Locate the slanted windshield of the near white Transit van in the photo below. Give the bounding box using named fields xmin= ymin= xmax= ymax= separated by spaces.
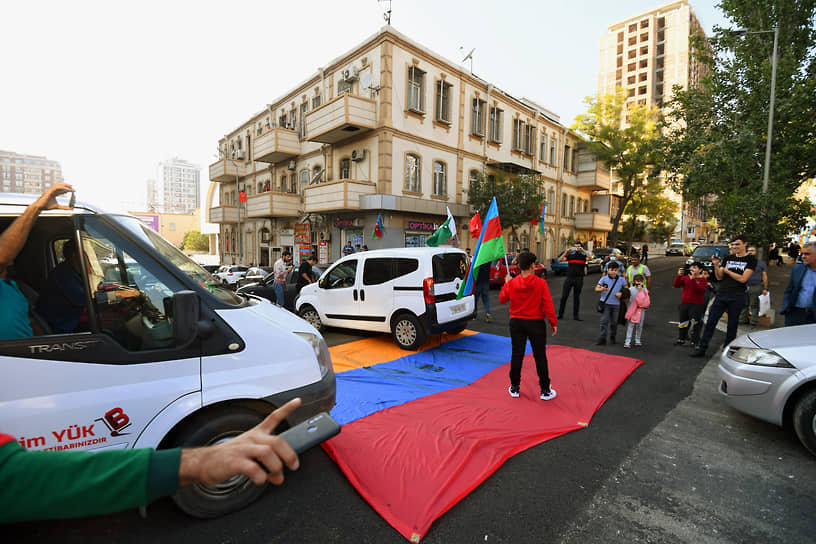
xmin=115 ymin=215 xmax=243 ymax=306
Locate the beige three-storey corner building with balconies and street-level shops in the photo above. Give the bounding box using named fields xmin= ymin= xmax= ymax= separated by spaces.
xmin=207 ymin=26 xmax=613 ymax=265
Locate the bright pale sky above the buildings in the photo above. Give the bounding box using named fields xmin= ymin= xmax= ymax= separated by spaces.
xmin=0 ymin=0 xmax=728 ymax=211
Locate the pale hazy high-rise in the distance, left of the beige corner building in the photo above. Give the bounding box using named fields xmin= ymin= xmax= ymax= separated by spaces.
xmin=147 ymin=157 xmax=201 ymax=214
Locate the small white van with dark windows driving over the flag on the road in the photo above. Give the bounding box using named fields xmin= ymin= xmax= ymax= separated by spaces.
xmin=295 ymin=247 xmax=475 ymax=350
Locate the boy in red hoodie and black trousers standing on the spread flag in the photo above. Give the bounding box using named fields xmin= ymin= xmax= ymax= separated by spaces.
xmin=499 ymin=251 xmax=558 ymax=400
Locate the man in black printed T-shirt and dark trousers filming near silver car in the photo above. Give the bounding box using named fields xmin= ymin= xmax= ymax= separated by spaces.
xmin=691 ymin=235 xmax=757 ymax=357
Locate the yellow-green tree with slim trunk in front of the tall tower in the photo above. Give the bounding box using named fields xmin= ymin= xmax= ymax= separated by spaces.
xmin=573 ymin=88 xmax=660 ymax=246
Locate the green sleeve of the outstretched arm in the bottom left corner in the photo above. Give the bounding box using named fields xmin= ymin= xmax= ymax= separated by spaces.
xmin=0 ymin=442 xmax=181 ymax=523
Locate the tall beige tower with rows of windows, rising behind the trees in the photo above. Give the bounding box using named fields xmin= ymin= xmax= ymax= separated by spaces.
xmin=598 ymin=0 xmax=708 ymax=240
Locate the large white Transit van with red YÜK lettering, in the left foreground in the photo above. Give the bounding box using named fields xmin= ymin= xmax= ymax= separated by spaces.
xmin=0 ymin=195 xmax=335 ymax=517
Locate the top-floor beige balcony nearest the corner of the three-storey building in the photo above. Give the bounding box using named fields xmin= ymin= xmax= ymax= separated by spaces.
xmin=306 ymin=93 xmax=377 ymax=144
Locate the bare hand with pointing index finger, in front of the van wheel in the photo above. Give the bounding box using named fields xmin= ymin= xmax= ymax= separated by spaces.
xmin=179 ymin=398 xmax=301 ymax=486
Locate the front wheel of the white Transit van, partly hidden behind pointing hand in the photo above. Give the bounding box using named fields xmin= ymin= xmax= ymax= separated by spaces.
xmin=172 ymin=408 xmax=266 ymax=519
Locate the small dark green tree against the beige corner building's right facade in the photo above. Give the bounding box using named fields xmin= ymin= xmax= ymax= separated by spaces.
xmin=466 ymin=172 xmax=544 ymax=234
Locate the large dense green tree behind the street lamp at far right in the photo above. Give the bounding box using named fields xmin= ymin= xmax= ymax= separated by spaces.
xmin=662 ymin=0 xmax=816 ymax=247
